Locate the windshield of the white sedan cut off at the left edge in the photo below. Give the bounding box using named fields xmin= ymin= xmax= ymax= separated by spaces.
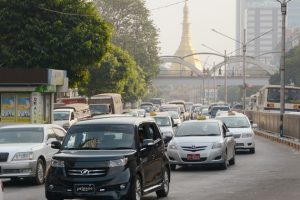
xmin=0 ymin=127 xmax=44 ymax=144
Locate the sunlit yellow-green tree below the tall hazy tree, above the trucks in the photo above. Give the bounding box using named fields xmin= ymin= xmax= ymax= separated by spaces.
xmin=81 ymin=45 xmax=145 ymax=102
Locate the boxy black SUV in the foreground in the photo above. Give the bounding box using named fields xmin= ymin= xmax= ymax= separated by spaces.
xmin=45 ymin=116 xmax=170 ymax=200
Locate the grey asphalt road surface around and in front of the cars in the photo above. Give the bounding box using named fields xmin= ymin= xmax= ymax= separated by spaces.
xmin=4 ymin=136 xmax=300 ymax=200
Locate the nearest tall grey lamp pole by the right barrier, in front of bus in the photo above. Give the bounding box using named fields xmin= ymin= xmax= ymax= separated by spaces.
xmin=276 ymin=0 xmax=291 ymax=137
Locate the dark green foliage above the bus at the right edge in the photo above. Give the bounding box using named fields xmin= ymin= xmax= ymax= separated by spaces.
xmin=269 ymin=45 xmax=300 ymax=86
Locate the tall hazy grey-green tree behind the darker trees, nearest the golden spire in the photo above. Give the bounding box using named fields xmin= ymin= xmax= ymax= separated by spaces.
xmin=94 ymin=0 xmax=159 ymax=83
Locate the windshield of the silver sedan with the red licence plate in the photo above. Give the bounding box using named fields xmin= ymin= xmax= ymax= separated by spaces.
xmin=175 ymin=122 xmax=221 ymax=137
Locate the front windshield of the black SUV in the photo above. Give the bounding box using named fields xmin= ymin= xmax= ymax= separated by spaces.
xmin=63 ymin=124 xmax=135 ymax=150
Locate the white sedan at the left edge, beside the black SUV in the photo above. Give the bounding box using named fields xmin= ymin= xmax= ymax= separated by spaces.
xmin=0 ymin=124 xmax=66 ymax=184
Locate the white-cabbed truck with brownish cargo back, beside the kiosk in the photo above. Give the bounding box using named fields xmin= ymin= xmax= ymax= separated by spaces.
xmin=53 ymin=103 xmax=91 ymax=130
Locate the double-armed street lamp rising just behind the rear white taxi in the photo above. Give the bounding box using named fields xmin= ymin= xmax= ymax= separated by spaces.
xmin=211 ymin=29 xmax=272 ymax=112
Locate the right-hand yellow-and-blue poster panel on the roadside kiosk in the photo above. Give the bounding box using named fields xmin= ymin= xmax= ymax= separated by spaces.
xmin=17 ymin=94 xmax=30 ymax=122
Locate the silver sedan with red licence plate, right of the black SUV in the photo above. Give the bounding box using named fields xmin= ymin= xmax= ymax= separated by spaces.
xmin=167 ymin=119 xmax=235 ymax=170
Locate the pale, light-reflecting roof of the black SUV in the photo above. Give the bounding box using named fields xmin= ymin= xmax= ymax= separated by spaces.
xmin=75 ymin=115 xmax=155 ymax=125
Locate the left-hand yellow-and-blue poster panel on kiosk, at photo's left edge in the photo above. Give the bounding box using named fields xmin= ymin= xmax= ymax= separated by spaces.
xmin=1 ymin=94 xmax=16 ymax=122
